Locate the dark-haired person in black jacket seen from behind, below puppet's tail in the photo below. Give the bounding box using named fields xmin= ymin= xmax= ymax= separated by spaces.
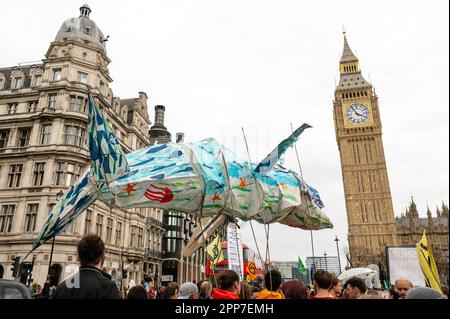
xmin=52 ymin=235 xmax=121 ymax=299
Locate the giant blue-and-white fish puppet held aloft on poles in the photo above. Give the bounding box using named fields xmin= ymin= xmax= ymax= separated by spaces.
xmin=28 ymin=94 xmax=333 ymax=254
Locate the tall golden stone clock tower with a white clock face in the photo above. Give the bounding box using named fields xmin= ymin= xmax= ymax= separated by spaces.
xmin=333 ymin=32 xmax=397 ymax=267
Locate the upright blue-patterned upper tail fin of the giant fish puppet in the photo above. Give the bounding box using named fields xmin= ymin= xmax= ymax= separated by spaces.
xmin=88 ymin=93 xmax=128 ymax=185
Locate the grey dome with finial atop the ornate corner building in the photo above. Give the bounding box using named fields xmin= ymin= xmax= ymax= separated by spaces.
xmin=56 ymin=4 xmax=106 ymax=49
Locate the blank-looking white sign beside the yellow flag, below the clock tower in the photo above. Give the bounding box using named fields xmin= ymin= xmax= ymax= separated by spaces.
xmin=388 ymin=247 xmax=425 ymax=287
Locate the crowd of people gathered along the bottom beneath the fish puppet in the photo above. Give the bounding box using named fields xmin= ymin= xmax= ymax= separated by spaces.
xmin=44 ymin=235 xmax=448 ymax=299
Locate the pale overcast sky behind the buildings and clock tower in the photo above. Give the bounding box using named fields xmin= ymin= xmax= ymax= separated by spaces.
xmin=0 ymin=0 xmax=449 ymax=260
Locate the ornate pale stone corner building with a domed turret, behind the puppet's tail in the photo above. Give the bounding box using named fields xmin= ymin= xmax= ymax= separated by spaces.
xmin=0 ymin=5 xmax=164 ymax=292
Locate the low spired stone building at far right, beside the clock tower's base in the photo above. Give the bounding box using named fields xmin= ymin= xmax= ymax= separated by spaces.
xmin=395 ymin=198 xmax=449 ymax=284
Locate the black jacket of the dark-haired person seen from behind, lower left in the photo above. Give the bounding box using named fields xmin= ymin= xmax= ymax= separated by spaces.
xmin=52 ymin=266 xmax=122 ymax=299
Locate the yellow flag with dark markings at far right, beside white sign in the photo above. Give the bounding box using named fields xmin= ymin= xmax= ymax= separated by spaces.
xmin=416 ymin=230 xmax=442 ymax=293
